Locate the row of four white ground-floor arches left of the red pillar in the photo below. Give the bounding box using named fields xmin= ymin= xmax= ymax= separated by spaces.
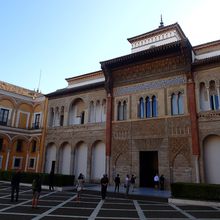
xmin=45 ymin=141 xmax=106 ymax=181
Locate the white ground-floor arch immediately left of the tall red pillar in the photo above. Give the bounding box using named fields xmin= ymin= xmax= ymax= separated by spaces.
xmin=92 ymin=141 xmax=106 ymax=180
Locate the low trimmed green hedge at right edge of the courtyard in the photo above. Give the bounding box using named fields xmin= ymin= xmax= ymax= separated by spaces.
xmin=171 ymin=183 xmax=220 ymax=201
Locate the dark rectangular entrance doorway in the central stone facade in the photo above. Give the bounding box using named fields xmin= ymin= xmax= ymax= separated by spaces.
xmin=139 ymin=151 xmax=158 ymax=187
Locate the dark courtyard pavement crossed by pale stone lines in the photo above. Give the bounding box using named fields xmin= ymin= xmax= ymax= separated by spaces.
xmin=0 ymin=182 xmax=220 ymax=220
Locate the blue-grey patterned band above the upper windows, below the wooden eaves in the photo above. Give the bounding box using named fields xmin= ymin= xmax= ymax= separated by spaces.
xmin=114 ymin=76 xmax=186 ymax=96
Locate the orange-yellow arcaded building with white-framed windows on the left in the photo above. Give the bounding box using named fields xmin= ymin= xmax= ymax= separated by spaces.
xmin=0 ymin=81 xmax=47 ymax=172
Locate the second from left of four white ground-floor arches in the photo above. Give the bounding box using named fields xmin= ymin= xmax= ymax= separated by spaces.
xmin=59 ymin=143 xmax=71 ymax=175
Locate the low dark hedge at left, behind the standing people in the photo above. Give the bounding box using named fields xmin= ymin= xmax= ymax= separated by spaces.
xmin=0 ymin=171 xmax=74 ymax=186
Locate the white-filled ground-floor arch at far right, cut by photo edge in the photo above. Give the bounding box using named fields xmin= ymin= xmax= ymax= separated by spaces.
xmin=203 ymin=135 xmax=220 ymax=184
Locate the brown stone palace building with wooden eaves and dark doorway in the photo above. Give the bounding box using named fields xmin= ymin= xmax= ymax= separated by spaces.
xmin=44 ymin=23 xmax=220 ymax=187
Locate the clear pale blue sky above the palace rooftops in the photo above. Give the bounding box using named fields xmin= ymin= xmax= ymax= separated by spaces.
xmin=0 ymin=0 xmax=220 ymax=94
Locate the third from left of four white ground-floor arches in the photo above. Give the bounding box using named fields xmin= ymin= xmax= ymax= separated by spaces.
xmin=74 ymin=142 xmax=88 ymax=178
